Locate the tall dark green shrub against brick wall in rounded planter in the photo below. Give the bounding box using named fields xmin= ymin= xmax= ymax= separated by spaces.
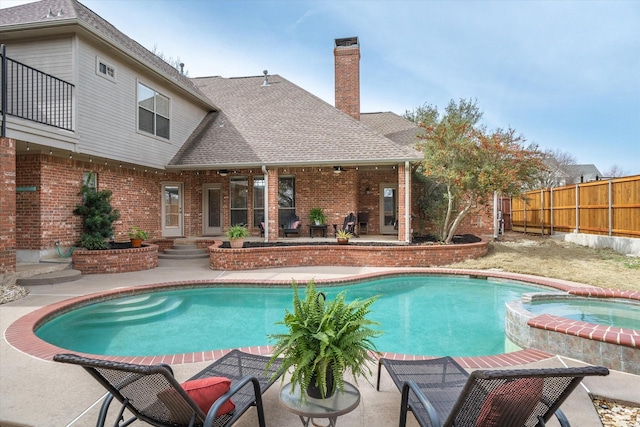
xmin=73 ymin=177 xmax=120 ymax=250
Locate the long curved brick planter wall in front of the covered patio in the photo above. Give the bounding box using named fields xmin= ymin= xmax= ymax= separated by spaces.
xmin=209 ymin=239 xmax=489 ymax=270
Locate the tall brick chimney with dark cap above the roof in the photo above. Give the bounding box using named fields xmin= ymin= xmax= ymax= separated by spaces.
xmin=333 ymin=37 xmax=360 ymax=121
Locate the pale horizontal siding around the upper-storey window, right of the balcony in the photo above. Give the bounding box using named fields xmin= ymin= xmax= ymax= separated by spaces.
xmin=76 ymin=40 xmax=207 ymax=168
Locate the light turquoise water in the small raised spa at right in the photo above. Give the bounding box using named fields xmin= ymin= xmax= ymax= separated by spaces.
xmin=523 ymin=298 xmax=640 ymax=330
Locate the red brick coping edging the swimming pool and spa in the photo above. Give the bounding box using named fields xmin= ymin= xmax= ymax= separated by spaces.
xmin=4 ymin=268 xmax=640 ymax=369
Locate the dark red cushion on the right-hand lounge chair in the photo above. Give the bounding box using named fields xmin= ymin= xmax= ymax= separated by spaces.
xmin=476 ymin=378 xmax=544 ymax=427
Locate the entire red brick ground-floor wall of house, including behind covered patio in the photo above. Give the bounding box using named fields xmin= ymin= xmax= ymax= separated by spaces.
xmin=15 ymin=155 xmax=493 ymax=263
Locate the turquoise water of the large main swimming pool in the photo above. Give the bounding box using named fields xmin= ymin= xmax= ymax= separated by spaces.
xmin=36 ymin=276 xmax=540 ymax=356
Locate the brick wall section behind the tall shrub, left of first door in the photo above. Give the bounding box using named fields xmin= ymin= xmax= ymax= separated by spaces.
xmin=16 ymin=153 xmax=172 ymax=250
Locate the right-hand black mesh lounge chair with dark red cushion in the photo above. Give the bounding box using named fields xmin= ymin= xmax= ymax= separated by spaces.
xmin=377 ymin=357 xmax=609 ymax=427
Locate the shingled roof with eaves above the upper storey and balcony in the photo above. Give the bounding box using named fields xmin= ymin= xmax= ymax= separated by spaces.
xmin=0 ymin=0 xmax=215 ymax=109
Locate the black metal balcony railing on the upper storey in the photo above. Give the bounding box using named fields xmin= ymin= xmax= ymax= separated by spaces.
xmin=0 ymin=45 xmax=74 ymax=136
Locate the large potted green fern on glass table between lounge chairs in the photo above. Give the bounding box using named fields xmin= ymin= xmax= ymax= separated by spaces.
xmin=269 ymin=280 xmax=382 ymax=400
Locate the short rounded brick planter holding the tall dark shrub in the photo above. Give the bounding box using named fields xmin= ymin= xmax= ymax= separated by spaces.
xmin=71 ymin=245 xmax=158 ymax=274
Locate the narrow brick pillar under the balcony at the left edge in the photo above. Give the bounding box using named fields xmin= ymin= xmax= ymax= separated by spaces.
xmin=0 ymin=138 xmax=16 ymax=274
